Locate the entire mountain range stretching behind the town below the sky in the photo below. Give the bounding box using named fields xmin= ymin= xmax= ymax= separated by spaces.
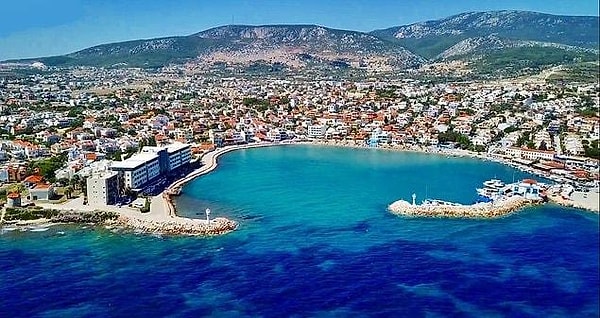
xmin=3 ymin=10 xmax=599 ymax=75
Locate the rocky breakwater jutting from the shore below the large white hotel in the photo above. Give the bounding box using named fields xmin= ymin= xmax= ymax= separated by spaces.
xmin=115 ymin=216 xmax=238 ymax=236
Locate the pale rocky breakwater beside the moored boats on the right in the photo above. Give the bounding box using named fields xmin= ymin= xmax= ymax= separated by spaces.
xmin=388 ymin=197 xmax=541 ymax=219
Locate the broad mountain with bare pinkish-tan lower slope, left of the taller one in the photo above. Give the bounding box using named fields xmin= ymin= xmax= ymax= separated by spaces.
xmin=9 ymin=25 xmax=423 ymax=67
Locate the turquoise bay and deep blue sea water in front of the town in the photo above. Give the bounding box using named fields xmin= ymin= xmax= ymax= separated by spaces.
xmin=0 ymin=145 xmax=600 ymax=317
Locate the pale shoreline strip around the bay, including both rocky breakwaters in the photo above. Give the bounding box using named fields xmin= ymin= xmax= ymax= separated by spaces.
xmin=0 ymin=140 xmax=599 ymax=236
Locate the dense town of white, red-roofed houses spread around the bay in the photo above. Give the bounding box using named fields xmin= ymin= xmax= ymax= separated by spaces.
xmin=0 ymin=65 xmax=600 ymax=210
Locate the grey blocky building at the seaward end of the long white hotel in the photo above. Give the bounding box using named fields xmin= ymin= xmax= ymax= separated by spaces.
xmin=86 ymin=171 xmax=119 ymax=206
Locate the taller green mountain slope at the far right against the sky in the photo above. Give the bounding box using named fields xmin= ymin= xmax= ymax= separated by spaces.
xmin=371 ymin=11 xmax=599 ymax=58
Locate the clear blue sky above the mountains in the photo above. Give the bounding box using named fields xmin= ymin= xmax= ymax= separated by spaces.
xmin=0 ymin=0 xmax=598 ymax=60
